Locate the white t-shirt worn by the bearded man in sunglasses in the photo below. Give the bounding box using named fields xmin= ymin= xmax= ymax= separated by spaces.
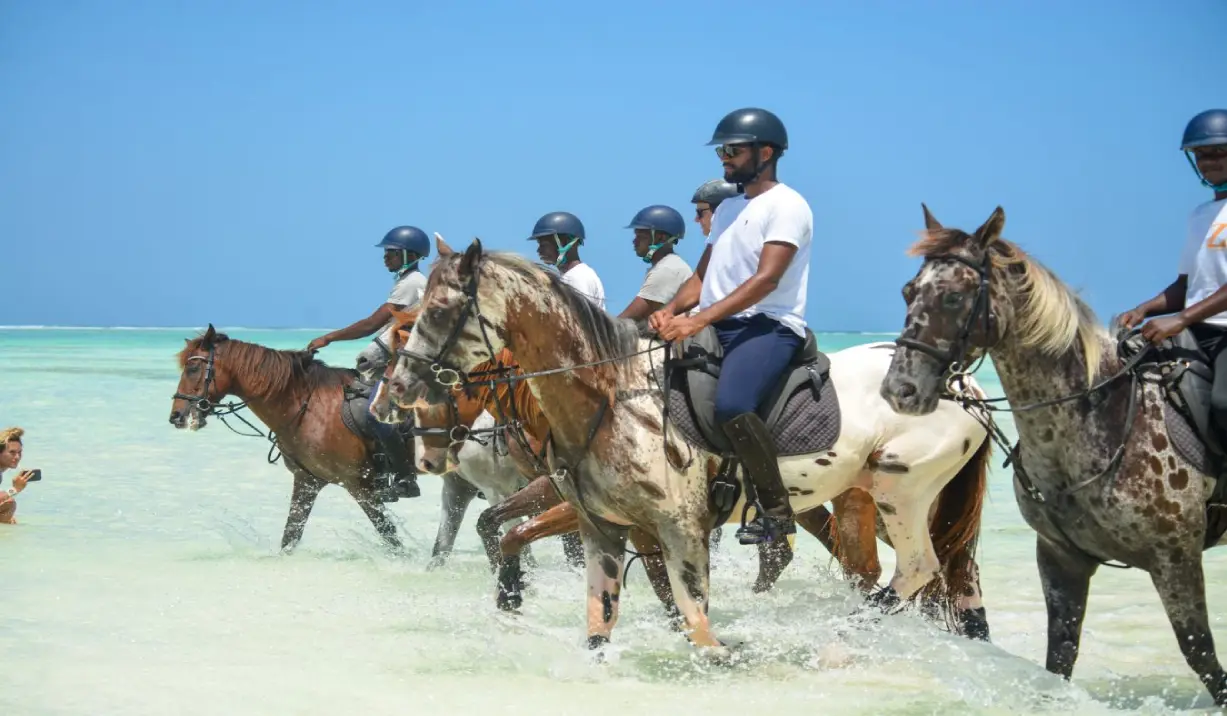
xmin=698 ymin=184 xmax=814 ymax=337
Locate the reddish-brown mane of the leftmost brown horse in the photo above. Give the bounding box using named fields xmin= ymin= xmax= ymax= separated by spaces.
xmin=178 ymin=333 xmax=357 ymax=397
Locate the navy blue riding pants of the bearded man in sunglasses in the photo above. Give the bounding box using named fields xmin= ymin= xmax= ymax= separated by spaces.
xmin=712 ymin=314 xmax=802 ymax=425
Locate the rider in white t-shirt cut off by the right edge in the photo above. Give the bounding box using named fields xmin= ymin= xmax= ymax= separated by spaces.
xmin=1118 ymin=109 xmax=1227 ymax=430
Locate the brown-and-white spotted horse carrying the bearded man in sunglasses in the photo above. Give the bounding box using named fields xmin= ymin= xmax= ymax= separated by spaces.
xmin=388 ymin=239 xmax=988 ymax=655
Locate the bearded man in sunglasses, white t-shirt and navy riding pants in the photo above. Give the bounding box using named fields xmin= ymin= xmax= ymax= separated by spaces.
xmin=650 ymin=108 xmax=814 ymax=544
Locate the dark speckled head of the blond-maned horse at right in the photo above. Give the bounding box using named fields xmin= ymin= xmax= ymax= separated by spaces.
xmin=881 ymin=205 xmax=1012 ymax=416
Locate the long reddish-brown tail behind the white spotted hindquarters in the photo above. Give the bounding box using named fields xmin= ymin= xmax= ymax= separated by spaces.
xmin=921 ymin=435 xmax=993 ymax=627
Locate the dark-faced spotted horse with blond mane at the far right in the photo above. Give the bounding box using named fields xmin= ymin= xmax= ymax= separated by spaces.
xmin=881 ymin=207 xmax=1227 ymax=705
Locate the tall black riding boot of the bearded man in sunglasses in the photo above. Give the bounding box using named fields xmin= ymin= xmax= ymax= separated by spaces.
xmin=724 ymin=413 xmax=796 ymax=544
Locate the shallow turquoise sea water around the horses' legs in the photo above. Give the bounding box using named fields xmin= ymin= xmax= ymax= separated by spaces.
xmin=0 ymin=329 xmax=1227 ymax=716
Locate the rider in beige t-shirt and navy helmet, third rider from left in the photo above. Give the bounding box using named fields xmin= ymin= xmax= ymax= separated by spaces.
xmin=618 ymin=204 xmax=693 ymax=321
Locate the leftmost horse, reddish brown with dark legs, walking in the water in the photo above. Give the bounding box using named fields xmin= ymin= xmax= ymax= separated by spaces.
xmin=171 ymin=324 xmax=401 ymax=552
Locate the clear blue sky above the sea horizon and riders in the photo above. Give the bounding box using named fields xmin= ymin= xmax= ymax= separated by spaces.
xmin=0 ymin=0 xmax=1227 ymax=331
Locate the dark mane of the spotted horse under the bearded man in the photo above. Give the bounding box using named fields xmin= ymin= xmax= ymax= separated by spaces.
xmin=485 ymin=251 xmax=642 ymax=379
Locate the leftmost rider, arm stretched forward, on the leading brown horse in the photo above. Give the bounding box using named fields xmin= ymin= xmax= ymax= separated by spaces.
xmin=307 ymin=227 xmax=431 ymax=499
